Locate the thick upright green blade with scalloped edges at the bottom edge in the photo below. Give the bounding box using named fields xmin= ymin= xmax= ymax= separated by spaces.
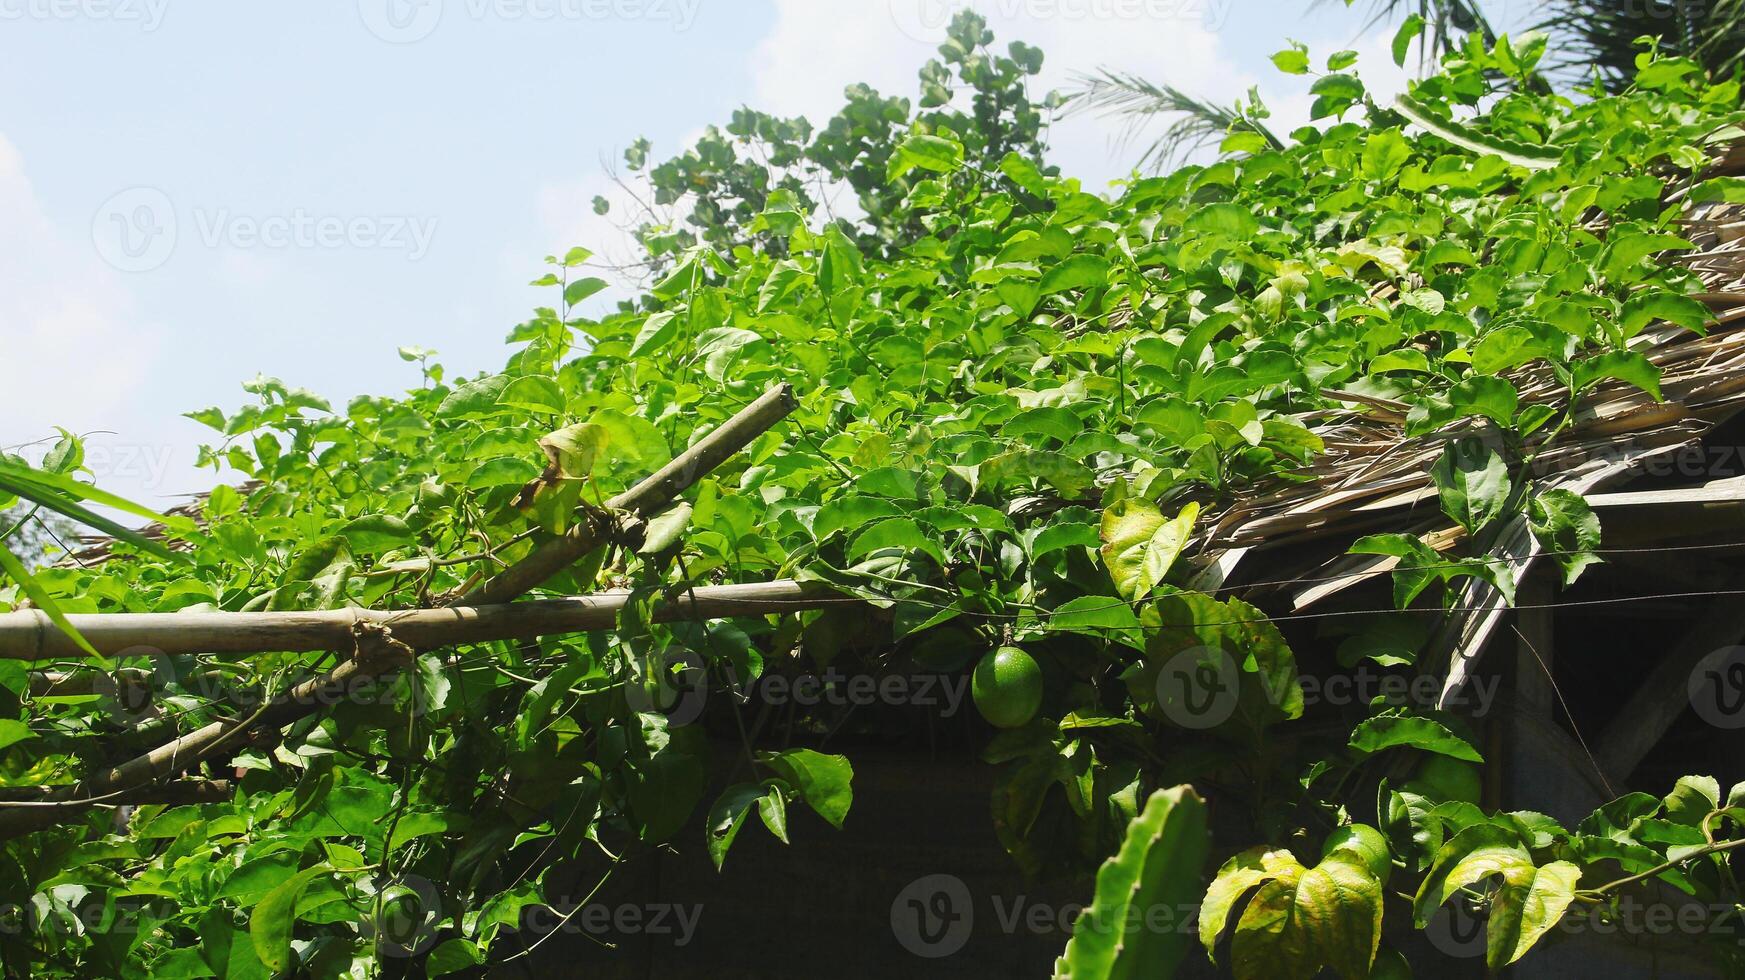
xmin=1054 ymin=786 xmax=1211 ymax=980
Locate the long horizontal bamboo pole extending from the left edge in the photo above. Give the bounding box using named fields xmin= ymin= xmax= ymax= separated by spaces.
xmin=0 ymin=579 xmax=853 ymax=659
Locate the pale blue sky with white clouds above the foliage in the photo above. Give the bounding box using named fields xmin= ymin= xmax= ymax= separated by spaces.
xmin=0 ymin=0 xmax=1528 ymax=506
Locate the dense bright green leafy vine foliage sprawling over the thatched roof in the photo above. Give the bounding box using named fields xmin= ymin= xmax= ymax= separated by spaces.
xmin=0 ymin=16 xmax=1745 ymax=977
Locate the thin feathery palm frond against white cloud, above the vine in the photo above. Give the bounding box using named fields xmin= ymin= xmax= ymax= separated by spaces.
xmin=1068 ymin=70 xmax=1284 ymax=173
